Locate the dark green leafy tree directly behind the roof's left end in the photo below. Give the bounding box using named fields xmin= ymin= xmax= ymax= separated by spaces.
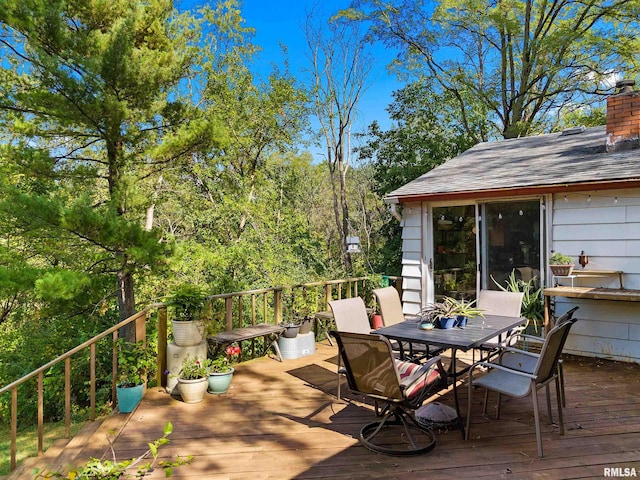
xmin=358 ymin=81 xmax=485 ymax=275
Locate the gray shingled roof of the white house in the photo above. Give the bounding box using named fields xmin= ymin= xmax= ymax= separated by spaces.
xmin=387 ymin=127 xmax=640 ymax=198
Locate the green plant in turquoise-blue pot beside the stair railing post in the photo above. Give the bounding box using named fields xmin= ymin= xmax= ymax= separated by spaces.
xmin=116 ymin=339 xmax=155 ymax=413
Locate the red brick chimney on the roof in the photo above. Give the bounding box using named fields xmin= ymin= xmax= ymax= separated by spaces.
xmin=607 ymin=80 xmax=640 ymax=152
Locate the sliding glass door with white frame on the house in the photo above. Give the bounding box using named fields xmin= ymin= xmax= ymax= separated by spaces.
xmin=426 ymin=199 xmax=544 ymax=301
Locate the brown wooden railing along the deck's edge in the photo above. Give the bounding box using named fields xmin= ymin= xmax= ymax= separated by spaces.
xmin=0 ymin=277 xmax=401 ymax=471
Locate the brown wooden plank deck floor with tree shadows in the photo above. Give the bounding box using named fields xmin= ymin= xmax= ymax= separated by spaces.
xmin=11 ymin=344 xmax=640 ymax=480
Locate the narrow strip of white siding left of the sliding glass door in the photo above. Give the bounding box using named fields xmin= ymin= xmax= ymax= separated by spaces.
xmin=402 ymin=203 xmax=422 ymax=313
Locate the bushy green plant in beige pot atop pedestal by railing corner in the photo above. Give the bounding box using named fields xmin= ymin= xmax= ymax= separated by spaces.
xmin=166 ymin=284 xmax=207 ymax=347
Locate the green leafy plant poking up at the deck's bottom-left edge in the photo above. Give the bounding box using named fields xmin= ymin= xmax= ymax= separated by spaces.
xmin=35 ymin=422 xmax=193 ymax=480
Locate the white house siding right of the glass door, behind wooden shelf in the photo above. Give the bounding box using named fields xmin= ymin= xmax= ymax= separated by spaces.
xmin=552 ymin=189 xmax=640 ymax=363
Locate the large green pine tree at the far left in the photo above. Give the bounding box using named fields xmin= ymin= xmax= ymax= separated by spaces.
xmin=0 ymin=0 xmax=238 ymax=340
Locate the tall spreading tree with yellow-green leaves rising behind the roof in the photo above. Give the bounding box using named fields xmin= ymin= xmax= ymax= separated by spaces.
xmin=349 ymin=0 xmax=640 ymax=142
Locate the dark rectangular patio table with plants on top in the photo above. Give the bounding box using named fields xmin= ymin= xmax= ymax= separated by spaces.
xmin=373 ymin=315 xmax=527 ymax=436
